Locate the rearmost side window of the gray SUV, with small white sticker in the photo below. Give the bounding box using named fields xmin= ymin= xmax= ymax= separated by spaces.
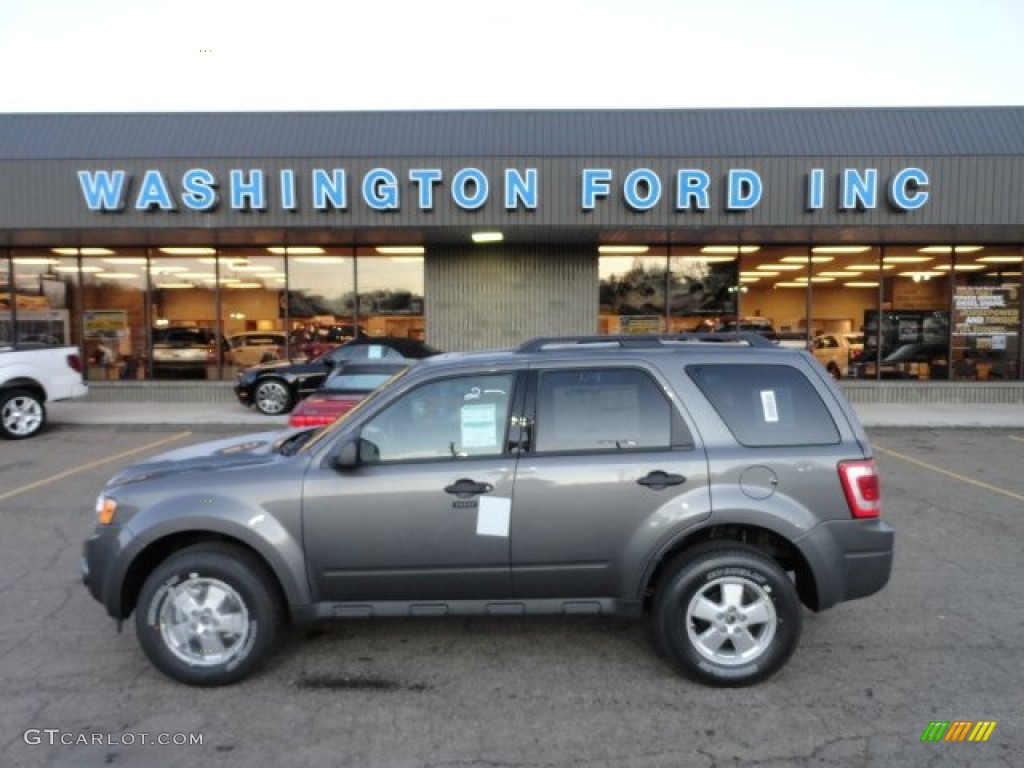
xmin=686 ymin=364 xmax=840 ymax=447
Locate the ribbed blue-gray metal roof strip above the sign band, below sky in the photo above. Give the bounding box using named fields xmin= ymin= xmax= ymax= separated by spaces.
xmin=0 ymin=108 xmax=1024 ymax=160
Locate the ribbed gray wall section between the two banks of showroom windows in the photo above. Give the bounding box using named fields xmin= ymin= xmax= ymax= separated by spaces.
xmin=424 ymin=246 xmax=598 ymax=350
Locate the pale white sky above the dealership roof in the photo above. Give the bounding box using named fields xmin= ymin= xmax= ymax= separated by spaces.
xmin=0 ymin=0 xmax=1024 ymax=112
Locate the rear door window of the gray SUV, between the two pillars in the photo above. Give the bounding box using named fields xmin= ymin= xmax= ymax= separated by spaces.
xmin=536 ymin=368 xmax=686 ymax=453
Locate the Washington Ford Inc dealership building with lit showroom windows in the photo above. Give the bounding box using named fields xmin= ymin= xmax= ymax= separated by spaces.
xmin=0 ymin=108 xmax=1024 ymax=384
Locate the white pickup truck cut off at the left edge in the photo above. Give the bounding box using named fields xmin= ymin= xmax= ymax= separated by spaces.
xmin=0 ymin=341 xmax=89 ymax=440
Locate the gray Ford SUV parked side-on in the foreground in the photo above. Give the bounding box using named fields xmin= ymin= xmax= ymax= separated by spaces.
xmin=82 ymin=334 xmax=893 ymax=686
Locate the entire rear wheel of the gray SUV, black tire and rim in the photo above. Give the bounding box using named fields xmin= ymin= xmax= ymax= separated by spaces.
xmin=652 ymin=544 xmax=803 ymax=687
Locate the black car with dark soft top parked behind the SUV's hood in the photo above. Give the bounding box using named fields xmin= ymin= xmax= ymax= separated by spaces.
xmin=234 ymin=336 xmax=438 ymax=416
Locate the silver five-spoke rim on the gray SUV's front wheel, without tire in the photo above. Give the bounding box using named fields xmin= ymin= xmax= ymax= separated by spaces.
xmin=160 ymin=575 xmax=250 ymax=667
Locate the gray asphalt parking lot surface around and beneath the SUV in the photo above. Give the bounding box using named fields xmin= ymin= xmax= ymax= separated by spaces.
xmin=0 ymin=425 xmax=1024 ymax=768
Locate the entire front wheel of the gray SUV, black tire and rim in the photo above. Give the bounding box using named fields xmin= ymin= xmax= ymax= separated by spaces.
xmin=135 ymin=544 xmax=285 ymax=686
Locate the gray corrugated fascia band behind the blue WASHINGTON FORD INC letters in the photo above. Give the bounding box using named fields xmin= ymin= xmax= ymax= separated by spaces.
xmin=8 ymin=154 xmax=1024 ymax=242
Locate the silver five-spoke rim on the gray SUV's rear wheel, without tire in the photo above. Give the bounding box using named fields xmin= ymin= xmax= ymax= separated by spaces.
xmin=686 ymin=575 xmax=778 ymax=667
